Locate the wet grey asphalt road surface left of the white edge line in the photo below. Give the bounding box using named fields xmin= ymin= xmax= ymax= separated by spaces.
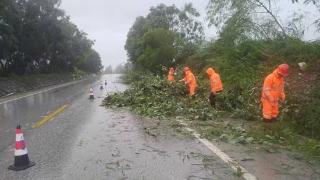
xmin=0 ymin=75 xmax=238 ymax=180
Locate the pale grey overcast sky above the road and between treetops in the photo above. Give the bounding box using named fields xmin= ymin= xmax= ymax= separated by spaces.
xmin=61 ymin=0 xmax=319 ymax=67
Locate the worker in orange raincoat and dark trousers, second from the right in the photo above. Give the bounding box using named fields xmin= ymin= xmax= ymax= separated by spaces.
xmin=206 ymin=68 xmax=223 ymax=107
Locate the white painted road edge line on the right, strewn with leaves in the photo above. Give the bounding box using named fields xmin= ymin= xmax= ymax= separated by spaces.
xmin=178 ymin=120 xmax=257 ymax=180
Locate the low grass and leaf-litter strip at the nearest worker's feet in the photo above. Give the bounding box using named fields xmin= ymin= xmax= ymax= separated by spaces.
xmin=190 ymin=118 xmax=320 ymax=162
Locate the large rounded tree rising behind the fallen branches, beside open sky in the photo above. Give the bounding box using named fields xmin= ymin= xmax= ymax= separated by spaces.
xmin=125 ymin=4 xmax=203 ymax=71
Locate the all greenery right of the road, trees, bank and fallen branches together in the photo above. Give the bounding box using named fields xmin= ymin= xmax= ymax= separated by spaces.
xmin=104 ymin=0 xmax=320 ymax=159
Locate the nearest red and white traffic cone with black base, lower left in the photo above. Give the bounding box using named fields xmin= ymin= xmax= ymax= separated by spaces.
xmin=8 ymin=125 xmax=36 ymax=171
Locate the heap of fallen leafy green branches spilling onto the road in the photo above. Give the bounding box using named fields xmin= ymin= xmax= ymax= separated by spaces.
xmin=104 ymin=75 xmax=221 ymax=120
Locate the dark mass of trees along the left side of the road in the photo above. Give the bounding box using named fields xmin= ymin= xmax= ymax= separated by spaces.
xmin=0 ymin=0 xmax=102 ymax=74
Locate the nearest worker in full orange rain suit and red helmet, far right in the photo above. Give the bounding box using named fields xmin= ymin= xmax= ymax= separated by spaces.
xmin=261 ymin=64 xmax=289 ymax=122
